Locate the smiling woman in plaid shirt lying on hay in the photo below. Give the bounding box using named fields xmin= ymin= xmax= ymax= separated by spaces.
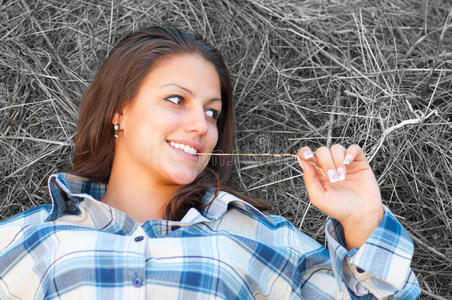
xmin=0 ymin=27 xmax=419 ymax=300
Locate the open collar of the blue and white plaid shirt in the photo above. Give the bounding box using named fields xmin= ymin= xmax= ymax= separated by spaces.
xmin=47 ymin=172 xmax=273 ymax=231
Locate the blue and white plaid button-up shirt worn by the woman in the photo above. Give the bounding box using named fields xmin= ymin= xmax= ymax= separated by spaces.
xmin=0 ymin=173 xmax=419 ymax=300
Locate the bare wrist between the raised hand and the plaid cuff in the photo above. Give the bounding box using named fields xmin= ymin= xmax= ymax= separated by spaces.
xmin=339 ymin=208 xmax=384 ymax=250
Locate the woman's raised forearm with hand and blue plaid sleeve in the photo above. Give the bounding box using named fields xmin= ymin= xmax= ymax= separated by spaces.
xmin=298 ymin=145 xmax=419 ymax=299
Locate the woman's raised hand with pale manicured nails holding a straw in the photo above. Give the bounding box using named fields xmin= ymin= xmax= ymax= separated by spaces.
xmin=298 ymin=144 xmax=384 ymax=250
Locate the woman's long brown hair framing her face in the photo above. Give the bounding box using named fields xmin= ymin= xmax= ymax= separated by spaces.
xmin=68 ymin=27 xmax=272 ymax=220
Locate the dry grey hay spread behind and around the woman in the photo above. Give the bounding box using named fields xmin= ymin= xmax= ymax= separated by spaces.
xmin=0 ymin=0 xmax=452 ymax=299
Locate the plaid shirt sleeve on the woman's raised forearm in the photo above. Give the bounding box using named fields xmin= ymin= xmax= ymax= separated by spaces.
xmin=325 ymin=206 xmax=420 ymax=299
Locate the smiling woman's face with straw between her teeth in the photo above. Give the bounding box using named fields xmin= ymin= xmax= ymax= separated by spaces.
xmin=113 ymin=54 xmax=222 ymax=185
